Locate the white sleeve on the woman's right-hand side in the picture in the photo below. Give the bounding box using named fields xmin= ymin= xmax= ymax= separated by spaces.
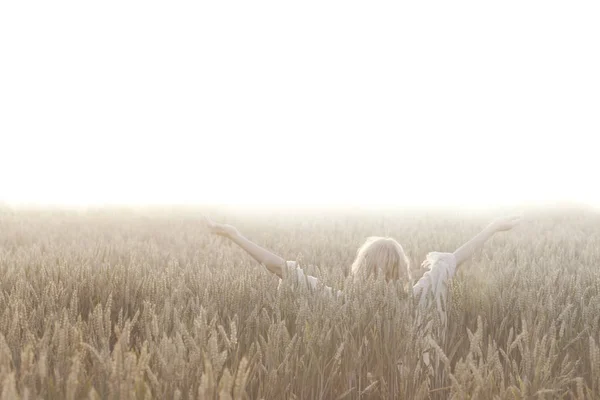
xmin=413 ymin=252 xmax=456 ymax=319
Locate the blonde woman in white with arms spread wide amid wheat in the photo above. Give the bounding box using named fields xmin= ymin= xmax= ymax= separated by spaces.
xmin=205 ymin=216 xmax=521 ymax=324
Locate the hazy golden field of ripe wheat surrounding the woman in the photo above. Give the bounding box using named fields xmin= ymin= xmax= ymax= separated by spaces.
xmin=0 ymin=207 xmax=600 ymax=399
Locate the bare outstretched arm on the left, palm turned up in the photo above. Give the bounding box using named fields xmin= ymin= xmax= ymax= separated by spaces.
xmin=204 ymin=217 xmax=285 ymax=278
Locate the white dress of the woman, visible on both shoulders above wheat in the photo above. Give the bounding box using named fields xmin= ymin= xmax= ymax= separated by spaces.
xmin=280 ymin=252 xmax=456 ymax=324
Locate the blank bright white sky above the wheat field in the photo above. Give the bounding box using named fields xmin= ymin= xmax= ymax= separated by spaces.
xmin=0 ymin=0 xmax=600 ymax=206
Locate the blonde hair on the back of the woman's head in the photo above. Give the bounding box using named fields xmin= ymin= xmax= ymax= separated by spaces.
xmin=352 ymin=236 xmax=411 ymax=281
